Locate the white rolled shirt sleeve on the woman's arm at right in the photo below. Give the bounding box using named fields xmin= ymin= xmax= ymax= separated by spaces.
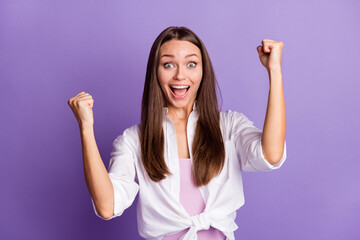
xmin=231 ymin=112 xmax=286 ymax=172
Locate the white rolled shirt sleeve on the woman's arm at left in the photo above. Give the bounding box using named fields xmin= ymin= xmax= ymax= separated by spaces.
xmin=91 ymin=126 xmax=139 ymax=220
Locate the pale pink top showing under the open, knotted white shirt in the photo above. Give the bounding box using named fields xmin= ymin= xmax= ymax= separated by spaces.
xmin=162 ymin=158 xmax=225 ymax=240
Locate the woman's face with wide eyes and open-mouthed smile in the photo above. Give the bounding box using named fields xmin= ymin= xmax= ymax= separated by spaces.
xmin=157 ymin=40 xmax=203 ymax=109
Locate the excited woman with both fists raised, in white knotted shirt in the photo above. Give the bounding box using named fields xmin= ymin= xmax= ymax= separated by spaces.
xmin=68 ymin=27 xmax=286 ymax=239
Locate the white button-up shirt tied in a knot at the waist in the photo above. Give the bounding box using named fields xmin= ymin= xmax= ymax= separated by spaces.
xmin=91 ymin=102 xmax=286 ymax=240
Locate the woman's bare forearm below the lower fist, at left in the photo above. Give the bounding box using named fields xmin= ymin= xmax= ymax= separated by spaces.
xmin=80 ymin=126 xmax=114 ymax=218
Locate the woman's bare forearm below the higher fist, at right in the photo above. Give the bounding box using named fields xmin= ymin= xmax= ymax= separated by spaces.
xmin=261 ymin=70 xmax=286 ymax=164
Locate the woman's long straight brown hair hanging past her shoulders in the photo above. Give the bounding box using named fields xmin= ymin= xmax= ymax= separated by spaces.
xmin=140 ymin=26 xmax=225 ymax=186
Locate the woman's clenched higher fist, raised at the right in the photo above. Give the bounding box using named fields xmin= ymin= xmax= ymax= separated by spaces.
xmin=256 ymin=39 xmax=284 ymax=72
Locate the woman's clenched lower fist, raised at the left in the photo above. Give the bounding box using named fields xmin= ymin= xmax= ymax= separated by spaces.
xmin=68 ymin=92 xmax=95 ymax=127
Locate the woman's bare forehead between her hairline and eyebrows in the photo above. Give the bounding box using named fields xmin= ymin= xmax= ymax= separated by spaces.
xmin=160 ymin=39 xmax=201 ymax=58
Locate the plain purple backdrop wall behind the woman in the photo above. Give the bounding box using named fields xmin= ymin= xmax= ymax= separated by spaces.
xmin=0 ymin=0 xmax=360 ymax=240
